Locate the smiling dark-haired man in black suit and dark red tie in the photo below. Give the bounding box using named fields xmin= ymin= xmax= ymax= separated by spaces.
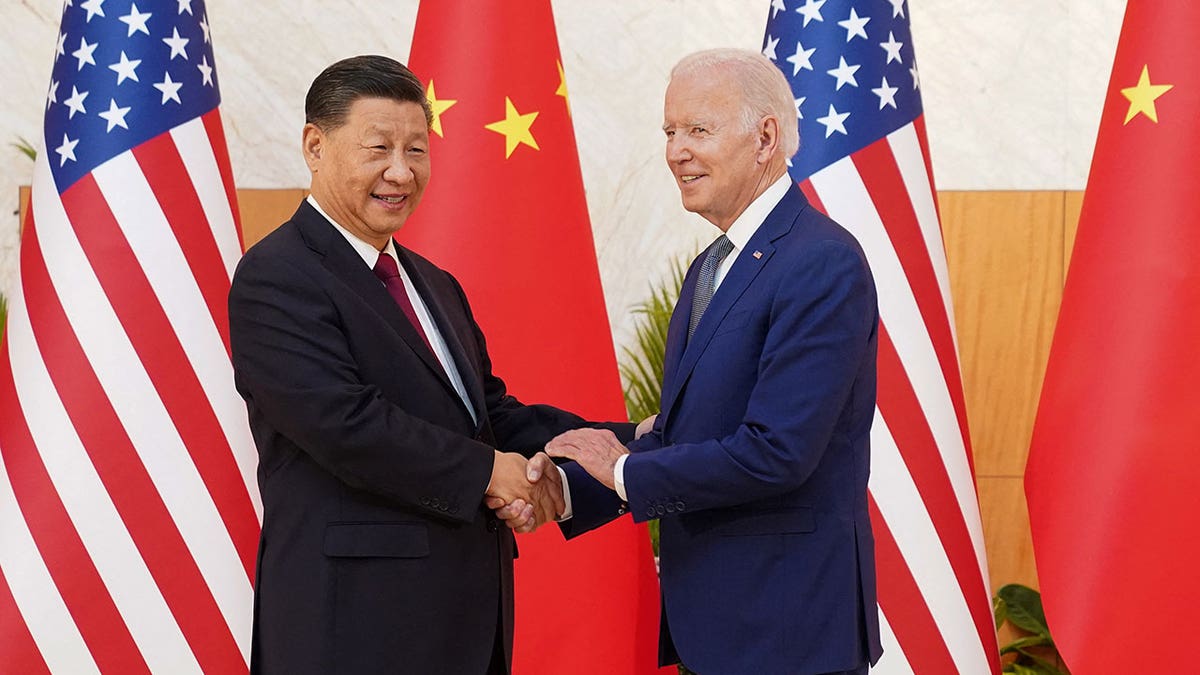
xmin=229 ymin=56 xmax=632 ymax=675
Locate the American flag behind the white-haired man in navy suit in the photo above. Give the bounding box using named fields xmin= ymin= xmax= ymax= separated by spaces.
xmin=762 ymin=0 xmax=1000 ymax=675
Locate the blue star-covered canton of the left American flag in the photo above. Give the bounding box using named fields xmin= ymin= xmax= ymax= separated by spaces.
xmin=44 ymin=0 xmax=221 ymax=192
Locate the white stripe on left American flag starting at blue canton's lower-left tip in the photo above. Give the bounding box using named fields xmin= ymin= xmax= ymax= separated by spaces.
xmin=35 ymin=149 xmax=253 ymax=655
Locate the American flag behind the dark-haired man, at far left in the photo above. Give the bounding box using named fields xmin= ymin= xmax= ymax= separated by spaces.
xmin=0 ymin=0 xmax=262 ymax=674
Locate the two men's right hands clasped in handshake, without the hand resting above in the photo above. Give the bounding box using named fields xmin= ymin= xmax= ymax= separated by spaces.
xmin=485 ymin=452 xmax=566 ymax=533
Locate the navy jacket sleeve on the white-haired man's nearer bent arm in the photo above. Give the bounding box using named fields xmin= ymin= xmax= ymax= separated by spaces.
xmin=624 ymin=241 xmax=878 ymax=520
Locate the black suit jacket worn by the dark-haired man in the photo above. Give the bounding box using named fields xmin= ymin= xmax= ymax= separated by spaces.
xmin=229 ymin=203 xmax=629 ymax=675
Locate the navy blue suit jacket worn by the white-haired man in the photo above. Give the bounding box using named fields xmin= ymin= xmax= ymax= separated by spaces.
xmin=564 ymin=186 xmax=881 ymax=674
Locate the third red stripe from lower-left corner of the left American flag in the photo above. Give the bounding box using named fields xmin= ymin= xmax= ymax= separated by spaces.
xmin=32 ymin=187 xmax=245 ymax=673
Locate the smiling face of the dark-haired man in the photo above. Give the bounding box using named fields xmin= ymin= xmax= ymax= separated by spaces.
xmin=304 ymin=98 xmax=430 ymax=250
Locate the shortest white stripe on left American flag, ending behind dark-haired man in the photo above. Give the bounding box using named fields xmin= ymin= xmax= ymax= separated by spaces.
xmin=170 ymin=118 xmax=241 ymax=279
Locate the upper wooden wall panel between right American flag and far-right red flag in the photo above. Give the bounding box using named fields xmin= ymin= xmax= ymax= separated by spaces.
xmin=938 ymin=192 xmax=1063 ymax=476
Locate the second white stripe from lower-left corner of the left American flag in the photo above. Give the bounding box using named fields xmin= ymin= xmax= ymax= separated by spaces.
xmin=7 ymin=269 xmax=199 ymax=673
